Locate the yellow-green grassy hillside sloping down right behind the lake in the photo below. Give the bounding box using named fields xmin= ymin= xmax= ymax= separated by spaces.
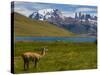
xmin=12 ymin=13 xmax=74 ymax=37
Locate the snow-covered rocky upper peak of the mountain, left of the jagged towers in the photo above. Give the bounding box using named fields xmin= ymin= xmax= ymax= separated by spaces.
xmin=29 ymin=9 xmax=63 ymax=20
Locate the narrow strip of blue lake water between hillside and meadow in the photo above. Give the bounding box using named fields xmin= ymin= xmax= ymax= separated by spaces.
xmin=16 ymin=37 xmax=96 ymax=42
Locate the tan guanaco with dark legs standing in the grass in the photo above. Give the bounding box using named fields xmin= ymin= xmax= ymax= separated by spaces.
xmin=22 ymin=48 xmax=46 ymax=70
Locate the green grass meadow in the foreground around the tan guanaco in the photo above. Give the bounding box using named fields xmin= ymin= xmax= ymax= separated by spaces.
xmin=14 ymin=42 xmax=97 ymax=73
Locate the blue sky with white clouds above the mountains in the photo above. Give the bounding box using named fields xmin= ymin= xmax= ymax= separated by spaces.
xmin=14 ymin=1 xmax=97 ymax=17
